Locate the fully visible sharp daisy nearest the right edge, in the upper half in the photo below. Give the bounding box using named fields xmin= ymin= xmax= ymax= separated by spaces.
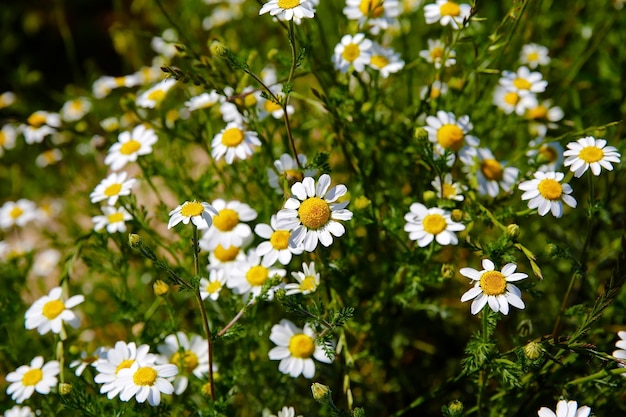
xmin=563 ymin=136 xmax=621 ymax=178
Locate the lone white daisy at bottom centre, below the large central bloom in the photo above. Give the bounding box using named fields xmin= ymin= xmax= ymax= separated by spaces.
xmin=269 ymin=319 xmax=333 ymax=379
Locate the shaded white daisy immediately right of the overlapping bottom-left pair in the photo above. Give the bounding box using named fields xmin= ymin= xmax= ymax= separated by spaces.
xmin=157 ymin=332 xmax=209 ymax=395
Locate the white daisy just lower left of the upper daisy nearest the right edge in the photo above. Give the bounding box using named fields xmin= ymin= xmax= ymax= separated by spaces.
xmin=519 ymin=171 xmax=576 ymax=217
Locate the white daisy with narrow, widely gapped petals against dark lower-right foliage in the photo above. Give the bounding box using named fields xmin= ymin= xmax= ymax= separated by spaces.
xmin=459 ymin=259 xmax=528 ymax=315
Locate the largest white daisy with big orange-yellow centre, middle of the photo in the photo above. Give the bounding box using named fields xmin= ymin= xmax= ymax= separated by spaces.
xmin=276 ymin=174 xmax=352 ymax=252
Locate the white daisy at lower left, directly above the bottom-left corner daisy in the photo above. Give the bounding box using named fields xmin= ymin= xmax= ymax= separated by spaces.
xmin=24 ymin=287 xmax=85 ymax=334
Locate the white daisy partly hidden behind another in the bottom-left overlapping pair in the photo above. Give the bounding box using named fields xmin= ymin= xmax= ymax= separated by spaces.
xmin=94 ymin=341 xmax=158 ymax=400
